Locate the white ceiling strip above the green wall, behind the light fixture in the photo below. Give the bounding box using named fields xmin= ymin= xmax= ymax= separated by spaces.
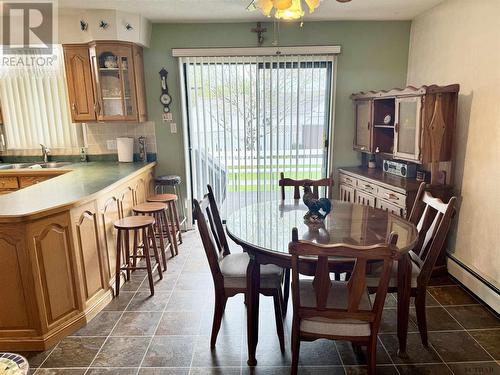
xmin=58 ymin=0 xmax=443 ymax=22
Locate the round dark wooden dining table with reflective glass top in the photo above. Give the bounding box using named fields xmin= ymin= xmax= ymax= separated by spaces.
xmin=226 ymin=200 xmax=418 ymax=366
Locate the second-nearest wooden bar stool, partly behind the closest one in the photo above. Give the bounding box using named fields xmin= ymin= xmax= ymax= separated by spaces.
xmin=132 ymin=202 xmax=174 ymax=271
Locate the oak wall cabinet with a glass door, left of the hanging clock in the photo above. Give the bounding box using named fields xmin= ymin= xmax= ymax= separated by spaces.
xmin=63 ymin=41 xmax=147 ymax=122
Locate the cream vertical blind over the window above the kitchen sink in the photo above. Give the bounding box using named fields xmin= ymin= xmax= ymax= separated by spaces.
xmin=0 ymin=46 xmax=78 ymax=150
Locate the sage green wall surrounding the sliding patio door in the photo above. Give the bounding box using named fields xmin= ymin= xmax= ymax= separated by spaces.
xmin=144 ymin=21 xmax=410 ymax=197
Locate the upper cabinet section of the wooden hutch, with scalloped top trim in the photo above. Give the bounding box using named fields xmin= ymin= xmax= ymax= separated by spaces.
xmin=351 ymin=84 xmax=459 ymax=164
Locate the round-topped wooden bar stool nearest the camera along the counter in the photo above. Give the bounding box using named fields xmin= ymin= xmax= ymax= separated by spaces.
xmin=114 ymin=216 xmax=163 ymax=296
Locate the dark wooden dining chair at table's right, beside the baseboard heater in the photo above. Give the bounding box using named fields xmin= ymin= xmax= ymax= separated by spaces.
xmin=367 ymin=182 xmax=457 ymax=346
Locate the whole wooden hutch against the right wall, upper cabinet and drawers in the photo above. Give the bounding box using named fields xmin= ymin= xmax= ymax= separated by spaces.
xmin=339 ymin=84 xmax=460 ymax=272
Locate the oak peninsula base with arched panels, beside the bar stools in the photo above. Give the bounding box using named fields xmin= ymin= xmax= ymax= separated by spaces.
xmin=0 ymin=163 xmax=155 ymax=351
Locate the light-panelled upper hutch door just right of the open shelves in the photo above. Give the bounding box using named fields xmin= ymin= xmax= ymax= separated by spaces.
xmin=394 ymin=96 xmax=422 ymax=161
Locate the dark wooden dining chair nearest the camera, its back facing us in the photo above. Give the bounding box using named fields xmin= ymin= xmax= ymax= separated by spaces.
xmin=288 ymin=228 xmax=398 ymax=374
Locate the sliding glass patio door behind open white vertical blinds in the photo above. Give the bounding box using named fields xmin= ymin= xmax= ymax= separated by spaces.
xmin=183 ymin=56 xmax=334 ymax=215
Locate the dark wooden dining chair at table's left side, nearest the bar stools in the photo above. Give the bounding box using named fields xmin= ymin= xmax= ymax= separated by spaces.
xmin=193 ymin=193 xmax=285 ymax=352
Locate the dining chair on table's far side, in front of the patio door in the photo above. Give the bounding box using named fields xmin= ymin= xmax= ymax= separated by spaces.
xmin=278 ymin=172 xmax=334 ymax=315
